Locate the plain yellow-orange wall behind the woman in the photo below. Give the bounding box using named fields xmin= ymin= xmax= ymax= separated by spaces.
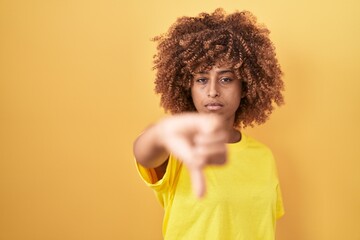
xmin=0 ymin=0 xmax=360 ymax=240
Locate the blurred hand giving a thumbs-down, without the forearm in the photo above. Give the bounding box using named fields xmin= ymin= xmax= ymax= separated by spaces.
xmin=158 ymin=113 xmax=228 ymax=197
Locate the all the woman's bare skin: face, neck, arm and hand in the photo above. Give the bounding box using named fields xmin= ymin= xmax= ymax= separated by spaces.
xmin=134 ymin=62 xmax=241 ymax=197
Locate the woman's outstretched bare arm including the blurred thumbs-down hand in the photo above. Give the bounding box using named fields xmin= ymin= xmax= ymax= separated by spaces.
xmin=134 ymin=113 xmax=228 ymax=196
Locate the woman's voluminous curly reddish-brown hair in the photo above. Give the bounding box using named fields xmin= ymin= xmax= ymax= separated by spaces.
xmin=152 ymin=8 xmax=284 ymax=127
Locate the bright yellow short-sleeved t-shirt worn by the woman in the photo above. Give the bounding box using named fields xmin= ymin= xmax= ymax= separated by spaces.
xmin=137 ymin=135 xmax=284 ymax=240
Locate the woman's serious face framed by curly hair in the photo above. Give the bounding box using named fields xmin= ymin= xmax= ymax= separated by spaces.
xmin=191 ymin=62 xmax=241 ymax=124
